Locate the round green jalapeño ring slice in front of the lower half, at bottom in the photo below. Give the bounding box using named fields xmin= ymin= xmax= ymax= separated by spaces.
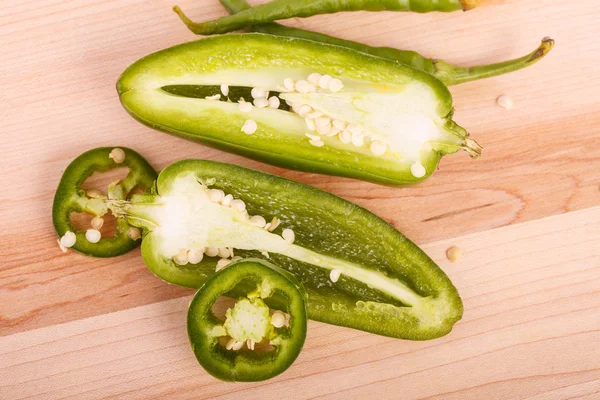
xmin=187 ymin=259 xmax=307 ymax=382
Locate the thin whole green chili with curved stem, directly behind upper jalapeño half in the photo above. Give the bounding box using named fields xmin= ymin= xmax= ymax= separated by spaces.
xmin=214 ymin=0 xmax=554 ymax=86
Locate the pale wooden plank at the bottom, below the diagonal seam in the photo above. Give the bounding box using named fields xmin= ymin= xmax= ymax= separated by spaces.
xmin=0 ymin=207 xmax=600 ymax=400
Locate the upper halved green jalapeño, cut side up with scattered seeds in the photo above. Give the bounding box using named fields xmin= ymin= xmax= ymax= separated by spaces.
xmin=117 ymin=33 xmax=481 ymax=185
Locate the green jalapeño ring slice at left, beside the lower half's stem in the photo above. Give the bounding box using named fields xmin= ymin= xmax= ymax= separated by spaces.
xmin=52 ymin=147 xmax=157 ymax=257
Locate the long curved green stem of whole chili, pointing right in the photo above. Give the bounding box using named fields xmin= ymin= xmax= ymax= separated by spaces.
xmin=434 ymin=37 xmax=554 ymax=85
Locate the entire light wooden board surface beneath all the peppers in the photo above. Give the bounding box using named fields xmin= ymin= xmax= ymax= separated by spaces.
xmin=0 ymin=0 xmax=600 ymax=400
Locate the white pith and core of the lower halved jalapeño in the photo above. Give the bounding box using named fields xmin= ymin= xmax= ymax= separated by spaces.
xmin=119 ymin=174 xmax=436 ymax=312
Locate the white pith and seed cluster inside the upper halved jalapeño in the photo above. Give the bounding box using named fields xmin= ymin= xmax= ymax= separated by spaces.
xmin=159 ymin=71 xmax=478 ymax=178
